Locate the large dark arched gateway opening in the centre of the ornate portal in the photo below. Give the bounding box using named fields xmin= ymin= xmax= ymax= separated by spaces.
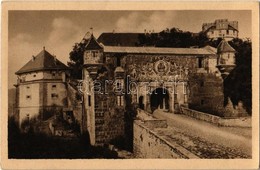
xmin=150 ymin=88 xmax=170 ymax=112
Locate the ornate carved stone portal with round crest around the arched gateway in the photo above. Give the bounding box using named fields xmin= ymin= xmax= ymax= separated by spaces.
xmin=126 ymin=56 xmax=189 ymax=112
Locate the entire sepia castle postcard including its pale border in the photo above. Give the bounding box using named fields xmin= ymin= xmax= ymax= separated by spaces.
xmin=1 ymin=2 xmax=259 ymax=169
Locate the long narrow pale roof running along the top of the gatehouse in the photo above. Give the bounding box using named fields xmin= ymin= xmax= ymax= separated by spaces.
xmin=104 ymin=46 xmax=216 ymax=55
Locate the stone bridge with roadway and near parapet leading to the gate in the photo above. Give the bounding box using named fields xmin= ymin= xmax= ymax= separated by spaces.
xmin=134 ymin=109 xmax=252 ymax=159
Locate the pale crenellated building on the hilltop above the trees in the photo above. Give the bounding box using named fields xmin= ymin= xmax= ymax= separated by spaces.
xmin=202 ymin=19 xmax=239 ymax=41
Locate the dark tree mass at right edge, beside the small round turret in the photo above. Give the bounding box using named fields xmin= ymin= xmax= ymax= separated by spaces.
xmin=224 ymin=38 xmax=252 ymax=114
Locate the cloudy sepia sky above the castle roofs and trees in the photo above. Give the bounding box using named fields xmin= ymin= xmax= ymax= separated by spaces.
xmin=8 ymin=10 xmax=251 ymax=88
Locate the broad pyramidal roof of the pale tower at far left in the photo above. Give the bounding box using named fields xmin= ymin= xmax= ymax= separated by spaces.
xmin=15 ymin=48 xmax=68 ymax=74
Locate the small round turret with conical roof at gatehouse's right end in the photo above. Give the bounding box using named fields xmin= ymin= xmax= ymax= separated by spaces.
xmin=217 ymin=40 xmax=236 ymax=79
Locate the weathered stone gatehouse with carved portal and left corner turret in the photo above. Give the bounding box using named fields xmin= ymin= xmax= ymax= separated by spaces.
xmin=83 ymin=35 xmax=240 ymax=145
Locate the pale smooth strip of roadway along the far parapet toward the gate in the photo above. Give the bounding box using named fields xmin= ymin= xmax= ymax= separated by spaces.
xmin=153 ymin=110 xmax=252 ymax=156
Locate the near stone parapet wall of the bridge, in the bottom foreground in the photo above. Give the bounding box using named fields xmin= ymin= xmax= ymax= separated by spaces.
xmin=133 ymin=109 xmax=198 ymax=159
